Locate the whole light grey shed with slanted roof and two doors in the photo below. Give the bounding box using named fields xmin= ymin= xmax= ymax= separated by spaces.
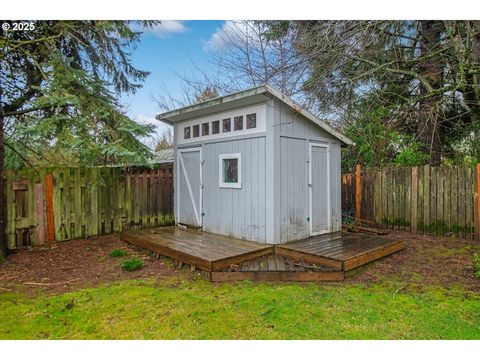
xmin=157 ymin=85 xmax=352 ymax=244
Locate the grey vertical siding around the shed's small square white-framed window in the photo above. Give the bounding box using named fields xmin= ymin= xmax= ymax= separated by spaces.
xmin=202 ymin=136 xmax=266 ymax=243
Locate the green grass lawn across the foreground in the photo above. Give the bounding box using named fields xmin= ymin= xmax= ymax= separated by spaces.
xmin=0 ymin=277 xmax=480 ymax=339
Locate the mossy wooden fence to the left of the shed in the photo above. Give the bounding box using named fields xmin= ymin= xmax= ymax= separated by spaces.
xmin=6 ymin=167 xmax=174 ymax=249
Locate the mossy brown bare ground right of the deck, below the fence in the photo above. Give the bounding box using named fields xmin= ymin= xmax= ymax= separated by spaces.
xmin=346 ymin=231 xmax=480 ymax=291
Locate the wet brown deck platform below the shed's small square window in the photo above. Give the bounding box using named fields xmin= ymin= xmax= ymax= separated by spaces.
xmin=121 ymin=226 xmax=273 ymax=271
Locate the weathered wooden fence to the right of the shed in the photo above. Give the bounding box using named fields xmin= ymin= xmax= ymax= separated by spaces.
xmin=342 ymin=164 xmax=480 ymax=239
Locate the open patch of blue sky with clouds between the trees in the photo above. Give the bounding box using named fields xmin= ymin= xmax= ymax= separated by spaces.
xmin=121 ymin=20 xmax=225 ymax=147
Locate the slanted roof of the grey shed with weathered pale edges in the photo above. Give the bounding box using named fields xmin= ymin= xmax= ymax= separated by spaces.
xmin=155 ymin=84 xmax=355 ymax=145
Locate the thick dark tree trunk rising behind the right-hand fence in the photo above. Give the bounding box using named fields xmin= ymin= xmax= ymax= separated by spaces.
xmin=417 ymin=21 xmax=443 ymax=165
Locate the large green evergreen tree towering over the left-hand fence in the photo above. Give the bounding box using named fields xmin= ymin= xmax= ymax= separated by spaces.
xmin=0 ymin=21 xmax=161 ymax=251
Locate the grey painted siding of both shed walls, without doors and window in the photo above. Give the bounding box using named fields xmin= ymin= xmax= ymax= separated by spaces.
xmin=175 ymin=99 xmax=341 ymax=243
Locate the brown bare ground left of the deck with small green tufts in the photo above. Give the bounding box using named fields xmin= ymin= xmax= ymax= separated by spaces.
xmin=0 ymin=235 xmax=189 ymax=293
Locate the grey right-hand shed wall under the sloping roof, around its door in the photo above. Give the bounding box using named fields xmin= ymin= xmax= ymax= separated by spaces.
xmin=273 ymin=100 xmax=342 ymax=243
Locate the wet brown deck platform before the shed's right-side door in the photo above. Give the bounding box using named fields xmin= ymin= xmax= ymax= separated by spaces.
xmin=275 ymin=232 xmax=405 ymax=271
